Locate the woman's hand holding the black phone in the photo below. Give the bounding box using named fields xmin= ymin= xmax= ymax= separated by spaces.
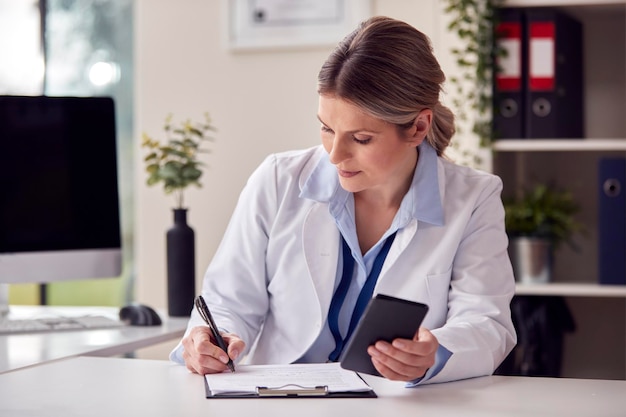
xmin=367 ymin=327 xmax=439 ymax=381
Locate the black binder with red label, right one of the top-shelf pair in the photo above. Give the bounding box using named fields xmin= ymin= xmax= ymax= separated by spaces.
xmin=525 ymin=8 xmax=584 ymax=138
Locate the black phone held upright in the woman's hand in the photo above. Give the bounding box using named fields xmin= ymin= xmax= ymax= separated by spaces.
xmin=339 ymin=294 xmax=428 ymax=376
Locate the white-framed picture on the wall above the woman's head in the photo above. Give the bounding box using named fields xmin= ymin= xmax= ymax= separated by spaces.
xmin=225 ymin=0 xmax=371 ymax=50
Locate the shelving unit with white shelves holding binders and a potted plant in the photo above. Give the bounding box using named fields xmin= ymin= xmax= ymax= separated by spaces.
xmin=493 ymin=0 xmax=626 ymax=379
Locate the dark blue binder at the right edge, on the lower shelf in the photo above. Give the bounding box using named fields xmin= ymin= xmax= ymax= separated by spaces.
xmin=598 ymin=158 xmax=626 ymax=285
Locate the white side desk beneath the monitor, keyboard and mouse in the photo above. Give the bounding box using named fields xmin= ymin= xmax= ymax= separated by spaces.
xmin=0 ymin=306 xmax=187 ymax=374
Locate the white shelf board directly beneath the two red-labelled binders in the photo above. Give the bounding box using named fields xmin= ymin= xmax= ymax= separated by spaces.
xmin=492 ymin=139 xmax=626 ymax=152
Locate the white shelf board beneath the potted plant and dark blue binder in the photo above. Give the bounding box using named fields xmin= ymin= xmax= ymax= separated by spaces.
xmin=515 ymin=283 xmax=626 ymax=298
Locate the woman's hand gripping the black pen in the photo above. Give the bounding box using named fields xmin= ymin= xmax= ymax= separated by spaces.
xmin=182 ymin=326 xmax=246 ymax=375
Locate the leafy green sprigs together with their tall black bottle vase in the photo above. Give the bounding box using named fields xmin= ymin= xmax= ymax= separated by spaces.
xmin=141 ymin=113 xmax=215 ymax=317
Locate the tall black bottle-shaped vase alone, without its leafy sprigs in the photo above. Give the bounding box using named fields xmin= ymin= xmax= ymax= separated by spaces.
xmin=167 ymin=209 xmax=196 ymax=317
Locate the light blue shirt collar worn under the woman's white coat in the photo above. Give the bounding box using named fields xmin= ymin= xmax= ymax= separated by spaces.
xmin=300 ymin=141 xmax=444 ymax=226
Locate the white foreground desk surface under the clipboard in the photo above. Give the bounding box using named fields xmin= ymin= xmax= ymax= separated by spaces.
xmin=0 ymin=357 xmax=626 ymax=417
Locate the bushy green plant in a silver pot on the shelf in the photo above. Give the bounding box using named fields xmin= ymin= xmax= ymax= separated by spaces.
xmin=504 ymin=184 xmax=582 ymax=283
